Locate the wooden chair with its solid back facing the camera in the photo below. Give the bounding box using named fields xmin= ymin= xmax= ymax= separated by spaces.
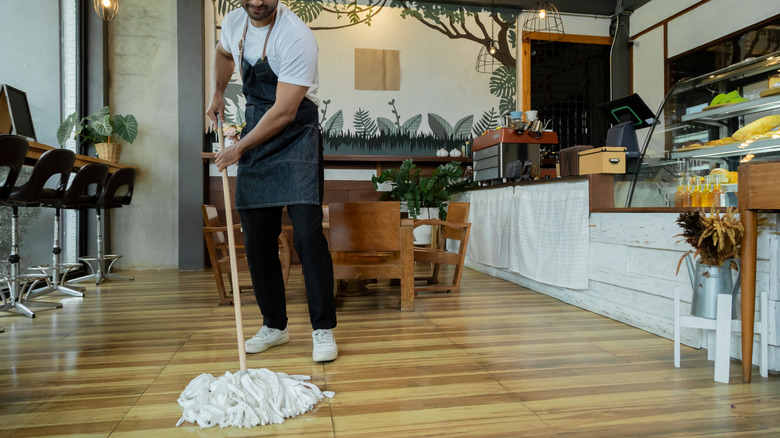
xmin=329 ymin=201 xmax=414 ymax=310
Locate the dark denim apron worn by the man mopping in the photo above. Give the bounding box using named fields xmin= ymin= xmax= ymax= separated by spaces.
xmin=236 ymin=9 xmax=323 ymax=210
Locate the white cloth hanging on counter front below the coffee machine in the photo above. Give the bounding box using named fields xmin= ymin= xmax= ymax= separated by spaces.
xmin=467 ymin=181 xmax=589 ymax=289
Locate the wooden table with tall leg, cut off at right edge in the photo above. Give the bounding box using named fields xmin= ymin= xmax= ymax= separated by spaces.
xmin=738 ymin=161 xmax=780 ymax=383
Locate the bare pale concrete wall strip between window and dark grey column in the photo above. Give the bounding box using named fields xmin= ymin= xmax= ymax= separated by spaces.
xmin=109 ymin=0 xmax=179 ymax=269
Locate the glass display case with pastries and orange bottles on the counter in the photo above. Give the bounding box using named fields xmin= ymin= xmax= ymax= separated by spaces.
xmin=615 ymin=52 xmax=780 ymax=207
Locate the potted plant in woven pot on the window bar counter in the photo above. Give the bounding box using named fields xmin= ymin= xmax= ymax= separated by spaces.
xmin=57 ymin=106 xmax=138 ymax=163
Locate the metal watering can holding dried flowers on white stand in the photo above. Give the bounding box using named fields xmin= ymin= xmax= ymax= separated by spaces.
xmin=685 ymin=254 xmax=741 ymax=319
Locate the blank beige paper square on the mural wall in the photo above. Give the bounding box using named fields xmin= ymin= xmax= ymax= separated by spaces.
xmin=355 ymin=49 xmax=401 ymax=91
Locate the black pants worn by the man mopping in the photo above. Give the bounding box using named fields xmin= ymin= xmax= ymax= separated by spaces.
xmin=239 ymin=205 xmax=336 ymax=330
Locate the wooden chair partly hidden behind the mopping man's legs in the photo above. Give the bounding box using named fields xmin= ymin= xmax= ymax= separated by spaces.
xmin=201 ymin=205 xmax=292 ymax=305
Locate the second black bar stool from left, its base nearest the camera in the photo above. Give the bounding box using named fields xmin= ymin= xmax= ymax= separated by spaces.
xmin=0 ymin=137 xmax=76 ymax=318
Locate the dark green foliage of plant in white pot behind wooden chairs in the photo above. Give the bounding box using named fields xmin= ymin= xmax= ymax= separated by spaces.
xmin=371 ymin=159 xmax=476 ymax=219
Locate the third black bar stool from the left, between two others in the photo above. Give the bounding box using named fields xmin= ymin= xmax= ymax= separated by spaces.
xmin=25 ymin=164 xmax=108 ymax=300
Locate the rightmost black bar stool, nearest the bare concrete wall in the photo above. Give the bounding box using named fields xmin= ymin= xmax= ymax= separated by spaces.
xmin=68 ymin=167 xmax=135 ymax=285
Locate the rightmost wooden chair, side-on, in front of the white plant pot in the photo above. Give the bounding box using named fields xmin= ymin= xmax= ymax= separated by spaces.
xmin=414 ymin=202 xmax=471 ymax=293
